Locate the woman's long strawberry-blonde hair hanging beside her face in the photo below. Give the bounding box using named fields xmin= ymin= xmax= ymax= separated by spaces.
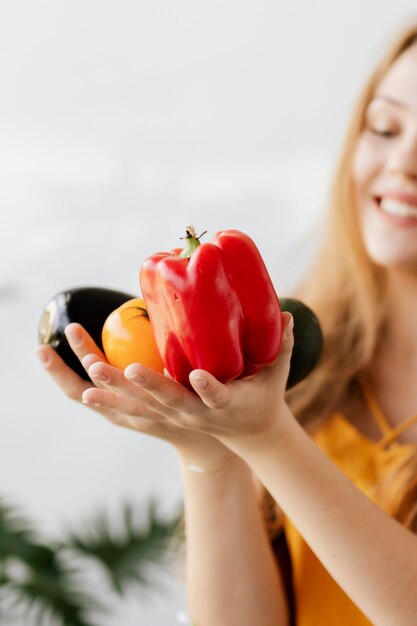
xmin=287 ymin=23 xmax=417 ymax=530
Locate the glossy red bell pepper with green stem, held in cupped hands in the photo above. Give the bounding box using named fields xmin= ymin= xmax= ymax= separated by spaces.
xmin=140 ymin=226 xmax=282 ymax=387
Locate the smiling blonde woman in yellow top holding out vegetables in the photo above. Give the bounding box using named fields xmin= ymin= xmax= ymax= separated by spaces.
xmin=39 ymin=26 xmax=417 ymax=626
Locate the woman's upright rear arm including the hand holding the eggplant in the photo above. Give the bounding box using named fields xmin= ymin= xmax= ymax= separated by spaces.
xmin=39 ymin=325 xmax=287 ymax=626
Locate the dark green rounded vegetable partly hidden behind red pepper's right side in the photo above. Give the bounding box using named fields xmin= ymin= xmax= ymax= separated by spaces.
xmin=279 ymin=298 xmax=323 ymax=389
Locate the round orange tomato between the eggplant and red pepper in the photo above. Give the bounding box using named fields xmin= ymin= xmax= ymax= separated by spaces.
xmin=102 ymin=298 xmax=164 ymax=372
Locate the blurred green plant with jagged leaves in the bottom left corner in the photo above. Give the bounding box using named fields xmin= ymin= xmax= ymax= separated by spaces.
xmin=0 ymin=498 xmax=182 ymax=626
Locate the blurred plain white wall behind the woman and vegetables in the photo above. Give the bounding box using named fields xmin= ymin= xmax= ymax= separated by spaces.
xmin=0 ymin=0 xmax=417 ymax=626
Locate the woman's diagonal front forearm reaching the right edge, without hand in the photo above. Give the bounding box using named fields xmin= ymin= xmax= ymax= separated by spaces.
xmin=236 ymin=411 xmax=417 ymax=626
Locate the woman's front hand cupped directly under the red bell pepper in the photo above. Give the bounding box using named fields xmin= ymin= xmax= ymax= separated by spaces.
xmin=83 ymin=312 xmax=293 ymax=451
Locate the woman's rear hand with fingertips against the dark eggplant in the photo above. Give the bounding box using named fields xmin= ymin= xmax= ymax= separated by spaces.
xmin=37 ymin=323 xmax=236 ymax=471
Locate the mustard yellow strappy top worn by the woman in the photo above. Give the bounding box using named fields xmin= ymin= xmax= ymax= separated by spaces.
xmin=284 ymin=388 xmax=417 ymax=626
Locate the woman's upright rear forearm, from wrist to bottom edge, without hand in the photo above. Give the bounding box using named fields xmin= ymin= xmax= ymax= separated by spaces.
xmin=182 ymin=458 xmax=288 ymax=626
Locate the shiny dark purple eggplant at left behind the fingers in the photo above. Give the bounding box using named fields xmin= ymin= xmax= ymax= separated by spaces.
xmin=39 ymin=287 xmax=134 ymax=380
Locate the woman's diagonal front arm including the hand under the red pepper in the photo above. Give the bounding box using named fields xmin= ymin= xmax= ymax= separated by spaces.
xmin=92 ymin=314 xmax=417 ymax=626
